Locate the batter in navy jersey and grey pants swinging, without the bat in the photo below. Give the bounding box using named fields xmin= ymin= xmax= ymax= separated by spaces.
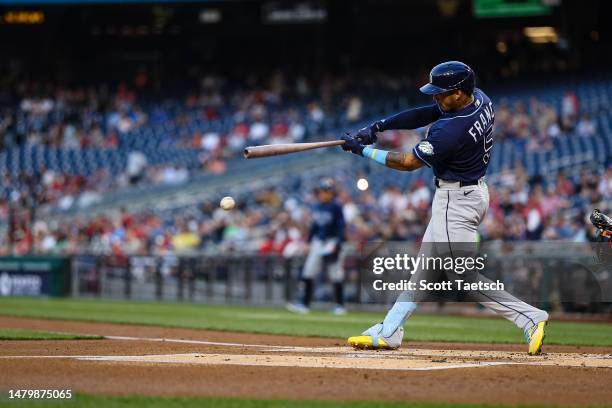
xmin=342 ymin=61 xmax=548 ymax=354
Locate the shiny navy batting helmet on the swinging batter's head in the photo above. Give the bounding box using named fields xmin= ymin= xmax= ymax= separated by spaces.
xmin=421 ymin=61 xmax=476 ymax=95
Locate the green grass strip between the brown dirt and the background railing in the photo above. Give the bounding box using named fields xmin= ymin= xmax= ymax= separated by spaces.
xmin=0 ymin=298 xmax=612 ymax=346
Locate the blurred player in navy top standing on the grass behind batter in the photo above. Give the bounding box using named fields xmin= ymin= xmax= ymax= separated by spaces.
xmin=287 ymin=179 xmax=346 ymax=315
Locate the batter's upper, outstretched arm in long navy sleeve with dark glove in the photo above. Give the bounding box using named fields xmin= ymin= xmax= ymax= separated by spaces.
xmin=351 ymin=104 xmax=442 ymax=145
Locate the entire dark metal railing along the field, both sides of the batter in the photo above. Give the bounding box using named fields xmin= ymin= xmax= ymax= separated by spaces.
xmin=71 ymin=251 xmax=612 ymax=312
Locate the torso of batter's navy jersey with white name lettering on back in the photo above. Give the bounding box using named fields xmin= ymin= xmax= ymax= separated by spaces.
xmin=413 ymin=88 xmax=495 ymax=181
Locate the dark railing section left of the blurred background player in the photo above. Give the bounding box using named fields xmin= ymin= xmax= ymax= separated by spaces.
xmin=72 ymin=254 xmax=318 ymax=304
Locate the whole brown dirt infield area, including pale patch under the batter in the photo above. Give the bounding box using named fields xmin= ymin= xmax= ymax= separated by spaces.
xmin=0 ymin=317 xmax=612 ymax=404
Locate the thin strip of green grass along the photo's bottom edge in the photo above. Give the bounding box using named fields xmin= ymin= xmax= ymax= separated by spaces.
xmin=0 ymin=394 xmax=596 ymax=408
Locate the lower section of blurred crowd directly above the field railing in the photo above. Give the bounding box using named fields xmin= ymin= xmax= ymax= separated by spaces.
xmin=0 ymin=167 xmax=612 ymax=257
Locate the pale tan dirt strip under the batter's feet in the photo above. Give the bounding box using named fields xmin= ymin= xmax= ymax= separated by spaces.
xmin=27 ymin=347 xmax=612 ymax=371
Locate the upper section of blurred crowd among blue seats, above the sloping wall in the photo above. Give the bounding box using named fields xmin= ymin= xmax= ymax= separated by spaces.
xmin=0 ymin=73 xmax=604 ymax=209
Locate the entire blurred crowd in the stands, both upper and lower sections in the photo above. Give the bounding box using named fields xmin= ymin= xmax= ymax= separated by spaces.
xmin=0 ymin=72 xmax=612 ymax=256
